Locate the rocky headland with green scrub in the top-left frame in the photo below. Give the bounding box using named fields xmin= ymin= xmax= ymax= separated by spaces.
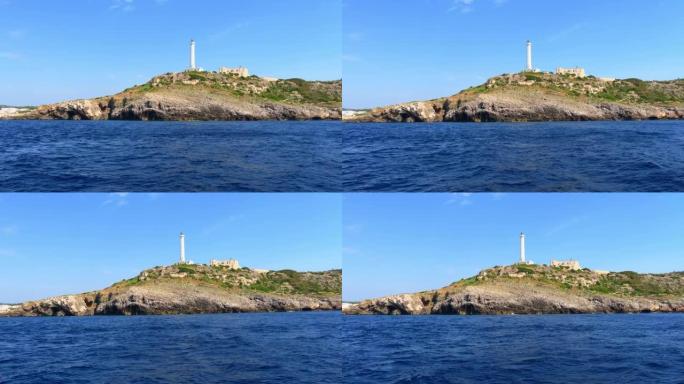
xmin=0 ymin=72 xmax=342 ymax=120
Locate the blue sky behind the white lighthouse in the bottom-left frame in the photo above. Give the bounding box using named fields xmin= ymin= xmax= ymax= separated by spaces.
xmin=0 ymin=193 xmax=342 ymax=303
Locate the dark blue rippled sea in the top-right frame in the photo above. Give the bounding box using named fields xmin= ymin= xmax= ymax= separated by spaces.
xmin=342 ymin=121 xmax=684 ymax=192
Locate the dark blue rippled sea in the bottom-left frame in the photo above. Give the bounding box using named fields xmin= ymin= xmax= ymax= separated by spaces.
xmin=0 ymin=312 xmax=342 ymax=384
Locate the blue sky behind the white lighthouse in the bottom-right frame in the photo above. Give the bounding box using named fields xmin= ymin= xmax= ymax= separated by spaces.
xmin=343 ymin=193 xmax=684 ymax=300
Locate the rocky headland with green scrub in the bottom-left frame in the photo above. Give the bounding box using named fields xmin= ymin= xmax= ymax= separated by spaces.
xmin=0 ymin=265 xmax=342 ymax=316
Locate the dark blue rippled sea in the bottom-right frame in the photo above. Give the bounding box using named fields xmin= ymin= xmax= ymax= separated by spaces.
xmin=342 ymin=314 xmax=684 ymax=384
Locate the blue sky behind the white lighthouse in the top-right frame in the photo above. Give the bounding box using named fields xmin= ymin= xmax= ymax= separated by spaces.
xmin=343 ymin=0 xmax=684 ymax=108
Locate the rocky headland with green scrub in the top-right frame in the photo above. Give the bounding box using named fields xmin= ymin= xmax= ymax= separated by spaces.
xmin=344 ymin=72 xmax=684 ymax=122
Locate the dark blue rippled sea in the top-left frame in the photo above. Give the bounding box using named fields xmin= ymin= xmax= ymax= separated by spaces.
xmin=0 ymin=121 xmax=341 ymax=192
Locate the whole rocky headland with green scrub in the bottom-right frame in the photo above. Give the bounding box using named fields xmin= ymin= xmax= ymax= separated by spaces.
xmin=344 ymin=265 xmax=684 ymax=315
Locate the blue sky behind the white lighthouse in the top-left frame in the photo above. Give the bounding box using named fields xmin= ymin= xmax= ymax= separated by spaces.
xmin=0 ymin=0 xmax=342 ymax=105
